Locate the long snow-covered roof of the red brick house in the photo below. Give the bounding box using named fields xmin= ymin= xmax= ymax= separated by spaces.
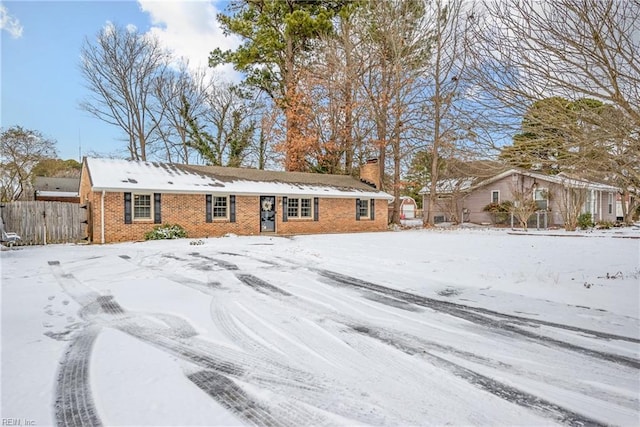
xmin=85 ymin=158 xmax=393 ymax=200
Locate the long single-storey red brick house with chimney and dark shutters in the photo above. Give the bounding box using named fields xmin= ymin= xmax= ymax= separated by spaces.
xmin=80 ymin=158 xmax=393 ymax=243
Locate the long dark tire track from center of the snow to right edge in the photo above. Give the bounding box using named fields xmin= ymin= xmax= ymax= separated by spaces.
xmin=315 ymin=270 xmax=640 ymax=369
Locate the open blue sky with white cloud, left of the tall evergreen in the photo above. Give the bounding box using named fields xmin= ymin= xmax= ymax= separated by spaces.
xmin=0 ymin=0 xmax=236 ymax=160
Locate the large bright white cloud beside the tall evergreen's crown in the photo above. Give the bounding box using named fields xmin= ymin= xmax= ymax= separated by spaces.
xmin=138 ymin=0 xmax=239 ymax=81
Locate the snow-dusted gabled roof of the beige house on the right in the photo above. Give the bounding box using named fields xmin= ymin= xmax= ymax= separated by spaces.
xmin=419 ymin=169 xmax=618 ymax=194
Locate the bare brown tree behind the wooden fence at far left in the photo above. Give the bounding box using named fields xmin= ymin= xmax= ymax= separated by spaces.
xmin=0 ymin=126 xmax=56 ymax=202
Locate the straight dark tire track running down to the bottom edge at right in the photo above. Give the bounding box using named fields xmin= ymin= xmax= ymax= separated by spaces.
xmin=352 ymin=326 xmax=607 ymax=427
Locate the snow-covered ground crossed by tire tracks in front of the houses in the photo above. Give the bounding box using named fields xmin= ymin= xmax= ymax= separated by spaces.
xmin=1 ymin=229 xmax=640 ymax=426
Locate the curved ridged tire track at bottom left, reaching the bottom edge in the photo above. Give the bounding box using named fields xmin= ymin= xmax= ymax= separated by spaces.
xmin=54 ymin=326 xmax=102 ymax=427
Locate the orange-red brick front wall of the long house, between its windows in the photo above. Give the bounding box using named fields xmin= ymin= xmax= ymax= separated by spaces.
xmin=85 ymin=191 xmax=388 ymax=243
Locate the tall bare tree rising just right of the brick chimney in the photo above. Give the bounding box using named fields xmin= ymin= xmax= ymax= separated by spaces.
xmin=361 ymin=0 xmax=432 ymax=223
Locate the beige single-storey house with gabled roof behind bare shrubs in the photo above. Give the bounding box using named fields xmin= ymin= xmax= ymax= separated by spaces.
xmin=420 ymin=169 xmax=618 ymax=226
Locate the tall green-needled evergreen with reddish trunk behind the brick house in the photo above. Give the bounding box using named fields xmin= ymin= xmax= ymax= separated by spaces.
xmin=209 ymin=0 xmax=346 ymax=170
